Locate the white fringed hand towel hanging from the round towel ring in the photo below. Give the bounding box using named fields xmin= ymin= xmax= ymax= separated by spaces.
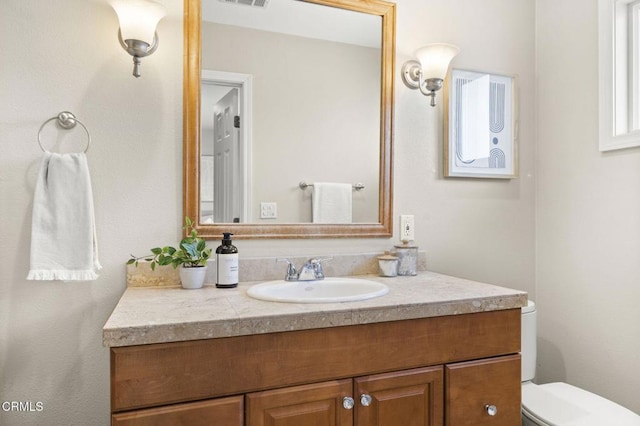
xmin=27 ymin=152 xmax=102 ymax=281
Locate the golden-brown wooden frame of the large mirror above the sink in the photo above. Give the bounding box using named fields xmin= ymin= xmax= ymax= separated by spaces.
xmin=183 ymin=0 xmax=395 ymax=239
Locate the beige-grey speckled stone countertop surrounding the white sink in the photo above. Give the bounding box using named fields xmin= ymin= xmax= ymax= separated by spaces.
xmin=103 ymin=271 xmax=527 ymax=347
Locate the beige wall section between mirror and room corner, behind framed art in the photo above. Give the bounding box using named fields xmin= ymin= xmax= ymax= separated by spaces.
xmin=395 ymin=0 xmax=535 ymax=293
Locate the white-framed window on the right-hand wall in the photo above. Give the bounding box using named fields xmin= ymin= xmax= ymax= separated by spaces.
xmin=598 ymin=0 xmax=640 ymax=151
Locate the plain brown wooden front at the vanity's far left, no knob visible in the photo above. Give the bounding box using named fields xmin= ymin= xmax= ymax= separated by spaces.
xmin=111 ymin=396 xmax=244 ymax=426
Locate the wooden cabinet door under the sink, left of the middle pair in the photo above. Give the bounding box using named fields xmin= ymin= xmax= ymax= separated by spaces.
xmin=246 ymin=379 xmax=353 ymax=426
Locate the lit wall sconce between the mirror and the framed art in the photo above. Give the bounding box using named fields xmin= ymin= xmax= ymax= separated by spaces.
xmin=402 ymin=43 xmax=460 ymax=107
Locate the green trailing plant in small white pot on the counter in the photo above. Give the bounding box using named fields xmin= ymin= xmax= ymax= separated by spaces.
xmin=127 ymin=216 xmax=211 ymax=289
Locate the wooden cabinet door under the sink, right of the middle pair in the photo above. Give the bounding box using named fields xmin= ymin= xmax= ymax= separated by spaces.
xmin=355 ymin=366 xmax=444 ymax=426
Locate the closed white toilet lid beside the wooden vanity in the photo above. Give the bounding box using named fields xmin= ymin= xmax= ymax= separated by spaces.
xmin=522 ymin=383 xmax=640 ymax=426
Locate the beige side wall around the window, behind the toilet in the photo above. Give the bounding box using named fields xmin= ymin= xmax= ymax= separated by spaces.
xmin=536 ymin=0 xmax=640 ymax=413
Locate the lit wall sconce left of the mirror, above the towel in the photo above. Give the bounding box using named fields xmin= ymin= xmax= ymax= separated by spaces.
xmin=110 ymin=0 xmax=167 ymax=77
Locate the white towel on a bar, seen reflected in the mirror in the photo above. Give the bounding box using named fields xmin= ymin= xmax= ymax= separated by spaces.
xmin=311 ymin=182 xmax=352 ymax=223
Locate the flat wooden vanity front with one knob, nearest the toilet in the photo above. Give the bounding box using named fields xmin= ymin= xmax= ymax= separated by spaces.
xmin=445 ymin=355 xmax=522 ymax=426
